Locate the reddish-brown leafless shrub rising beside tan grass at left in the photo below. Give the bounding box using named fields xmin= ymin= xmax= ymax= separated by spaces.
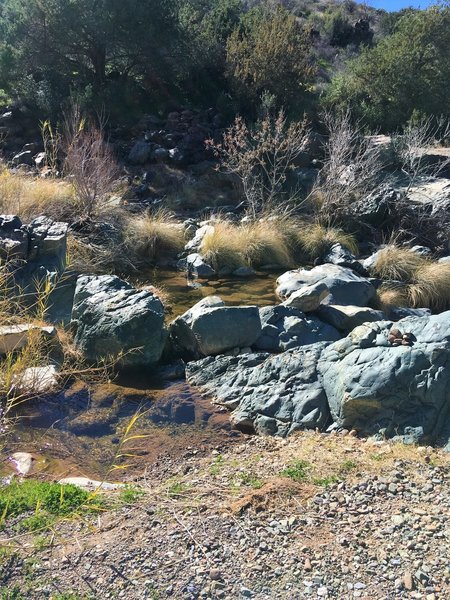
xmin=63 ymin=106 xmax=119 ymax=218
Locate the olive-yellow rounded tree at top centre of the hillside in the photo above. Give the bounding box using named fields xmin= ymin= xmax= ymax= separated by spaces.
xmin=227 ymin=6 xmax=314 ymax=113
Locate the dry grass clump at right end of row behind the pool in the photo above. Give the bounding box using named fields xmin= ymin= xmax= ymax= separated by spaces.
xmin=292 ymin=222 xmax=358 ymax=261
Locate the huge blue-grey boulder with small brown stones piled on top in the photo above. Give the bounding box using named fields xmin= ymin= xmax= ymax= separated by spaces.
xmin=318 ymin=312 xmax=450 ymax=442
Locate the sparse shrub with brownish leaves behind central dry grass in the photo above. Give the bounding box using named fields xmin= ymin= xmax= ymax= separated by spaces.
xmin=207 ymin=111 xmax=310 ymax=218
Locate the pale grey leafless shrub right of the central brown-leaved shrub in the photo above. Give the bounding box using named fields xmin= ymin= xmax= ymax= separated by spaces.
xmin=311 ymin=111 xmax=384 ymax=219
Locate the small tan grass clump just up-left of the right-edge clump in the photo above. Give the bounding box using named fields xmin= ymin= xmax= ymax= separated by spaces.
xmin=372 ymin=244 xmax=429 ymax=282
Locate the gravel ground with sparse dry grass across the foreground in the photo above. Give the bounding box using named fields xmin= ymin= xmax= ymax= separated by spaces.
xmin=0 ymin=433 xmax=450 ymax=600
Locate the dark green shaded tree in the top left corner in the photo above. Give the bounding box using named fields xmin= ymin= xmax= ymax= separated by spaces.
xmin=0 ymin=0 xmax=184 ymax=114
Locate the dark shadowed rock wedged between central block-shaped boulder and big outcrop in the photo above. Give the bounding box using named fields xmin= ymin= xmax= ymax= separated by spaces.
xmin=254 ymin=304 xmax=341 ymax=352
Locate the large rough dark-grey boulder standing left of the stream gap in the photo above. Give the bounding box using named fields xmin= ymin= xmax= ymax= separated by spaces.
xmin=71 ymin=275 xmax=167 ymax=367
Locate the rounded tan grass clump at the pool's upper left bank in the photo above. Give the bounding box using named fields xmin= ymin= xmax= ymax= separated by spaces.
xmin=125 ymin=210 xmax=185 ymax=264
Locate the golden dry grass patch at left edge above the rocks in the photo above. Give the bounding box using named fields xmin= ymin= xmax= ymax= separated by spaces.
xmin=0 ymin=169 xmax=75 ymax=221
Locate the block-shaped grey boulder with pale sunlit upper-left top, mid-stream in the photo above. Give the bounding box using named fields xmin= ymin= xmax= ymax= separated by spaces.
xmin=170 ymin=296 xmax=261 ymax=359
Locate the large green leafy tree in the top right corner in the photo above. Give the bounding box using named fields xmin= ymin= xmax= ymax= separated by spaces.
xmin=326 ymin=6 xmax=450 ymax=131
